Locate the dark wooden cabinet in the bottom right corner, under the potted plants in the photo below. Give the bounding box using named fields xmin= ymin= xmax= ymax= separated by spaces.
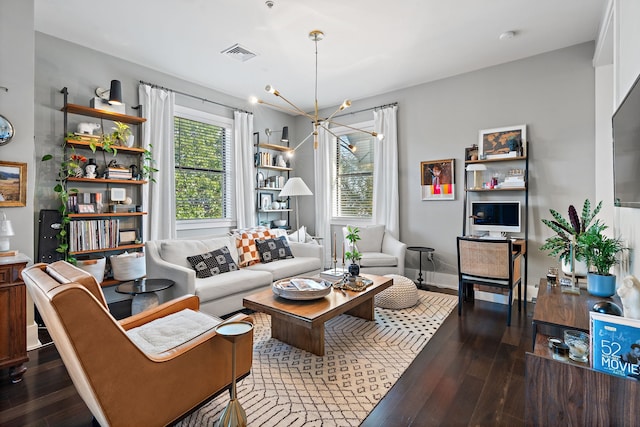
xmin=525 ymin=279 xmax=640 ymax=426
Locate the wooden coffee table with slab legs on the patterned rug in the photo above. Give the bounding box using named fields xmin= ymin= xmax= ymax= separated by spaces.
xmin=242 ymin=274 xmax=393 ymax=356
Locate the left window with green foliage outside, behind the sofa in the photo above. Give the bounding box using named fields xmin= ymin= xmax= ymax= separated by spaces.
xmin=174 ymin=106 xmax=233 ymax=222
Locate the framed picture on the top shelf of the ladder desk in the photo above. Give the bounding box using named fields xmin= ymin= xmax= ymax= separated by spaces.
xmin=478 ymin=125 xmax=527 ymax=159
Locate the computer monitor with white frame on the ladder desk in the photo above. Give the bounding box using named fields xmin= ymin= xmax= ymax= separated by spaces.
xmin=471 ymin=201 xmax=521 ymax=239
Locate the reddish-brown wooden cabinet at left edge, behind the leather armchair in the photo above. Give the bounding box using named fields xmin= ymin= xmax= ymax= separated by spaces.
xmin=0 ymin=254 xmax=29 ymax=383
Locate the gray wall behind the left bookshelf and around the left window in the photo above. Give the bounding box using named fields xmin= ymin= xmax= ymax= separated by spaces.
xmin=35 ymin=33 xmax=295 ymax=238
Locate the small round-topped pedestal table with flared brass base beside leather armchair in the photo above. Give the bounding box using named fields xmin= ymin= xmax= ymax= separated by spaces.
xmin=215 ymin=322 xmax=253 ymax=427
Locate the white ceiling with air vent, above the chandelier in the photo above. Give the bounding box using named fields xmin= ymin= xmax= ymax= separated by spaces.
xmin=35 ymin=0 xmax=607 ymax=110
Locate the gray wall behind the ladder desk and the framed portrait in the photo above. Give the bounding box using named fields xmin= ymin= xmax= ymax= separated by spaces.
xmin=297 ymin=43 xmax=595 ymax=290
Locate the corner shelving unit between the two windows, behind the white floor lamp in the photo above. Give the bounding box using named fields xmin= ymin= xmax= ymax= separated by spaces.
xmin=254 ymin=132 xmax=293 ymax=229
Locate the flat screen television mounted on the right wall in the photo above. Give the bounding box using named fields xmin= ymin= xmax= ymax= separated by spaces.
xmin=612 ymin=72 xmax=640 ymax=208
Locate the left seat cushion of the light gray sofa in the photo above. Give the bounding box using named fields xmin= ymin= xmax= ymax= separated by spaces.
xmin=195 ymin=270 xmax=273 ymax=301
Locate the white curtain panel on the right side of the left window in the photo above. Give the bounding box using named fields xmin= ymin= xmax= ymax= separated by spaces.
xmin=233 ymin=111 xmax=257 ymax=228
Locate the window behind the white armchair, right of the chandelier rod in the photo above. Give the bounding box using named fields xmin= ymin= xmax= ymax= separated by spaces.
xmin=331 ymin=122 xmax=375 ymax=219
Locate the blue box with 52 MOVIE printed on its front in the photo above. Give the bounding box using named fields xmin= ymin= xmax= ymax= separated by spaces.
xmin=589 ymin=312 xmax=640 ymax=380
